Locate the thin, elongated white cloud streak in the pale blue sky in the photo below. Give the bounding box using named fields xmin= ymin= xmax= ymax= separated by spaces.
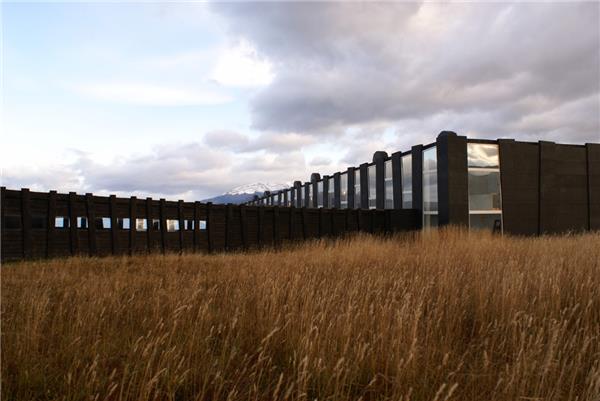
xmin=75 ymin=82 xmax=231 ymax=106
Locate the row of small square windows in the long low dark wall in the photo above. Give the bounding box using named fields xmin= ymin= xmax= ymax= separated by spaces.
xmin=4 ymin=215 xmax=206 ymax=232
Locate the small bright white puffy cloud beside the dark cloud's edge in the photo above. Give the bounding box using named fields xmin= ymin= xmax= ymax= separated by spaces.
xmin=211 ymin=40 xmax=273 ymax=87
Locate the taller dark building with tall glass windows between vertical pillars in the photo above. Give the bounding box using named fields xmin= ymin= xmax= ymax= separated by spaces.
xmin=249 ymin=131 xmax=600 ymax=235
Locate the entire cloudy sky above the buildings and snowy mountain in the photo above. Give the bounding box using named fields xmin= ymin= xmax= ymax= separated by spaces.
xmin=0 ymin=2 xmax=600 ymax=201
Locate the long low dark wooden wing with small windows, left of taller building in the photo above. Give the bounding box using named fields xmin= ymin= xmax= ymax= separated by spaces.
xmin=0 ymin=187 xmax=421 ymax=261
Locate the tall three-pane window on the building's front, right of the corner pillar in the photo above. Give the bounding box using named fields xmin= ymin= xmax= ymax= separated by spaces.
xmin=467 ymin=143 xmax=502 ymax=232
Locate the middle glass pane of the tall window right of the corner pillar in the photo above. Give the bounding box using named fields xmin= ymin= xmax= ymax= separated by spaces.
xmin=469 ymin=169 xmax=502 ymax=211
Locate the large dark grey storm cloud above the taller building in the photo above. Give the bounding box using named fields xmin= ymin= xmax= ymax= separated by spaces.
xmin=213 ymin=3 xmax=600 ymax=142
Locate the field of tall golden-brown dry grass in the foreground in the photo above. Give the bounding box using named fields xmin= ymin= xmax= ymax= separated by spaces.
xmin=1 ymin=229 xmax=600 ymax=401
